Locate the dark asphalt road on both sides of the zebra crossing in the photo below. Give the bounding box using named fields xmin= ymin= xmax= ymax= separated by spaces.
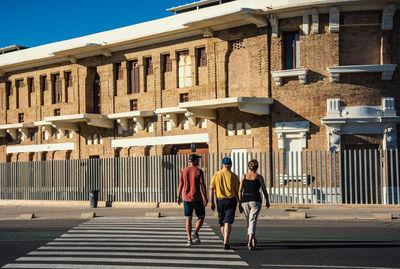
xmin=0 ymin=219 xmax=400 ymax=269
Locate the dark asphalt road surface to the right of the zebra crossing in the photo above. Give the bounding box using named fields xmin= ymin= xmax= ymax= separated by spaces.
xmin=207 ymin=220 xmax=400 ymax=268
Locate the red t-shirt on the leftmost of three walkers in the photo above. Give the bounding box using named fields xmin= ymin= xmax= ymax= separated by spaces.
xmin=179 ymin=166 xmax=204 ymax=202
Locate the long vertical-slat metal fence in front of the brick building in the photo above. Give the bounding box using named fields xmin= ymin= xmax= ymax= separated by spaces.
xmin=0 ymin=149 xmax=400 ymax=204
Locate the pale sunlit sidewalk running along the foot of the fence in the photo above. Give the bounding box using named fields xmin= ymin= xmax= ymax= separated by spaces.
xmin=0 ymin=201 xmax=400 ymax=221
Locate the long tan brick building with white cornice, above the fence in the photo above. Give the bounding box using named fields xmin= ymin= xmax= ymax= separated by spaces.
xmin=0 ymin=0 xmax=400 ymax=162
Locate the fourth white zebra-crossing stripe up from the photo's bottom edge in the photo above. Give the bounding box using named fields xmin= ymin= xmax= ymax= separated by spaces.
xmin=39 ymin=245 xmax=234 ymax=253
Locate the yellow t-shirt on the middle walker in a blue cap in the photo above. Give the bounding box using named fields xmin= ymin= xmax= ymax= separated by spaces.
xmin=210 ymin=168 xmax=240 ymax=199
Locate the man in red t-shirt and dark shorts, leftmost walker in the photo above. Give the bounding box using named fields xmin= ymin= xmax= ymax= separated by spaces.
xmin=177 ymin=154 xmax=208 ymax=246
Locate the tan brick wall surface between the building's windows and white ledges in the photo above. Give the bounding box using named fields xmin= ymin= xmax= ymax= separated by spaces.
xmin=0 ymin=8 xmax=400 ymax=162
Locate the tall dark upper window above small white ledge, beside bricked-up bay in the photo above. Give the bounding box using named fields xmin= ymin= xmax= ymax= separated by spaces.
xmin=283 ymin=32 xmax=300 ymax=69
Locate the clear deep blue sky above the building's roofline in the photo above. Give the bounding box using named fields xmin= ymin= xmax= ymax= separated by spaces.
xmin=0 ymin=0 xmax=195 ymax=48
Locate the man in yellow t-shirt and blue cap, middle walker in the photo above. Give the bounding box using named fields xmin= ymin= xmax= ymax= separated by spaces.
xmin=210 ymin=157 xmax=240 ymax=249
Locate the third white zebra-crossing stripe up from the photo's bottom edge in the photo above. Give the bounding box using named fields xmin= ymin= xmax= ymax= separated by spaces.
xmin=28 ymin=250 xmax=240 ymax=259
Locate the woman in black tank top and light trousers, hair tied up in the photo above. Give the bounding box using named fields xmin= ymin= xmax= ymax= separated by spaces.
xmin=239 ymin=159 xmax=270 ymax=250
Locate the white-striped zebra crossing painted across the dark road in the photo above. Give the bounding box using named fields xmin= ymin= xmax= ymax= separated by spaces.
xmin=2 ymin=218 xmax=248 ymax=269
